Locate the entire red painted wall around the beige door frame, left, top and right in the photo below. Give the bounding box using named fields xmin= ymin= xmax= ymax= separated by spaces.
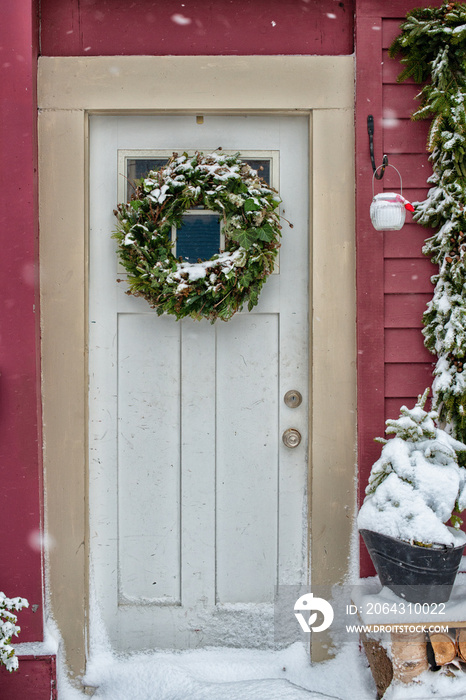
xmin=5 ymin=0 xmax=448 ymax=698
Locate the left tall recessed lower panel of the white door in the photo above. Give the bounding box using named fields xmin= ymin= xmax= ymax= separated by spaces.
xmin=117 ymin=313 xmax=181 ymax=604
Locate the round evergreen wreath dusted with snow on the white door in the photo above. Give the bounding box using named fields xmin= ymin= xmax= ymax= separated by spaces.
xmin=113 ymin=152 xmax=281 ymax=323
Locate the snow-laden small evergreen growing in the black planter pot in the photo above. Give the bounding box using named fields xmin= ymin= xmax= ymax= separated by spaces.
xmin=358 ymin=389 xmax=466 ymax=546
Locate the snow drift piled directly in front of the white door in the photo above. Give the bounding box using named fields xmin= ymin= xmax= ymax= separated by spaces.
xmin=79 ymin=642 xmax=375 ymax=700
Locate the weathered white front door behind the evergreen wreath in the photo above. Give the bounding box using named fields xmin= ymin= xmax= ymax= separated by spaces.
xmin=89 ymin=115 xmax=309 ymax=650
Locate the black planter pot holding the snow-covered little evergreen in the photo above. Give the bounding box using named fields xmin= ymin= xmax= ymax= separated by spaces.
xmin=360 ymin=530 xmax=465 ymax=603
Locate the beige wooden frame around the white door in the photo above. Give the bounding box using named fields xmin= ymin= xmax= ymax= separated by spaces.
xmin=38 ymin=56 xmax=356 ymax=676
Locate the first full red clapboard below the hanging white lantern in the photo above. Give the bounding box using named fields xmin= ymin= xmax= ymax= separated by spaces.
xmin=384 ymin=258 xmax=437 ymax=294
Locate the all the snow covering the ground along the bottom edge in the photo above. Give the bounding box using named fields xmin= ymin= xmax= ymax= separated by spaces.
xmin=15 ymin=621 xmax=466 ymax=700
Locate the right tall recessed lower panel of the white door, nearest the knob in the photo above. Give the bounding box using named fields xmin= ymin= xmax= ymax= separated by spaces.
xmin=217 ymin=314 xmax=279 ymax=603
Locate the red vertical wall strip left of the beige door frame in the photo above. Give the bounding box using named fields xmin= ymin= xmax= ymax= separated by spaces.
xmin=0 ymin=0 xmax=43 ymax=642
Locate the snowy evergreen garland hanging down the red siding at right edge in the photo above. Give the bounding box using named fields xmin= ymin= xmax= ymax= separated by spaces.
xmin=389 ymin=2 xmax=466 ymax=442
